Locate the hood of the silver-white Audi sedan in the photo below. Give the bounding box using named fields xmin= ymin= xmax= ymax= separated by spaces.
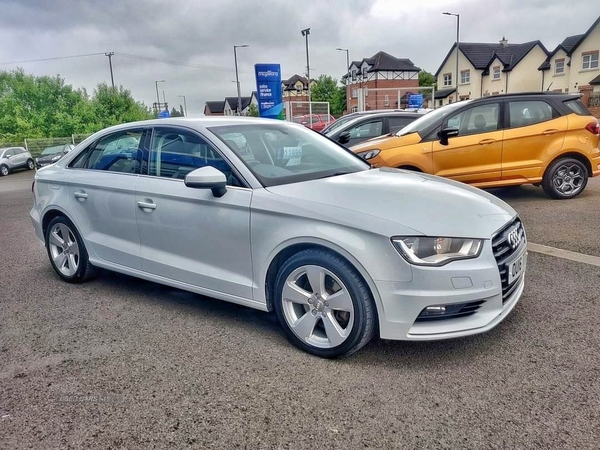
xmin=267 ymin=168 xmax=516 ymax=239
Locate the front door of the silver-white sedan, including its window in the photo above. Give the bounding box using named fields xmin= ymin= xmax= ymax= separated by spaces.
xmin=135 ymin=127 xmax=252 ymax=299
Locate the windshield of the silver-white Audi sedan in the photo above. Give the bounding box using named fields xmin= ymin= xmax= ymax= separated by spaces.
xmin=209 ymin=122 xmax=370 ymax=187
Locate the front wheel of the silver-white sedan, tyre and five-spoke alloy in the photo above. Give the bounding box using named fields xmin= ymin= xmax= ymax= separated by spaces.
xmin=273 ymin=249 xmax=376 ymax=358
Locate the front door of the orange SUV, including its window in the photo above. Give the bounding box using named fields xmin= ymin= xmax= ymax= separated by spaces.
xmin=433 ymin=102 xmax=503 ymax=183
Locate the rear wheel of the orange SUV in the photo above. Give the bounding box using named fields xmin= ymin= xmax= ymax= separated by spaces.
xmin=542 ymin=158 xmax=588 ymax=199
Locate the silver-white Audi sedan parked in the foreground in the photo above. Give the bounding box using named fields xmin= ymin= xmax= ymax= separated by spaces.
xmin=30 ymin=117 xmax=527 ymax=357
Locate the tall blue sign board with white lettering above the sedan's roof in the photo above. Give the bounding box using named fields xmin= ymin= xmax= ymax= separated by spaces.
xmin=254 ymin=64 xmax=283 ymax=120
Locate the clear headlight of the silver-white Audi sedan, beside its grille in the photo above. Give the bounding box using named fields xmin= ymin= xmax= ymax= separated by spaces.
xmin=392 ymin=236 xmax=483 ymax=266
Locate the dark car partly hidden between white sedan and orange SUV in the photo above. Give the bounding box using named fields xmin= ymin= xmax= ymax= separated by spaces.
xmin=322 ymin=110 xmax=428 ymax=147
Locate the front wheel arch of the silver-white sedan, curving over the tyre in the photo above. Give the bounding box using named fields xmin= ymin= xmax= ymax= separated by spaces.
xmin=263 ymin=241 xmax=381 ymax=326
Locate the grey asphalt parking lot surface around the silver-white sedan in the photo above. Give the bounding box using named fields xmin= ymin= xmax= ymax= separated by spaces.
xmin=0 ymin=172 xmax=600 ymax=449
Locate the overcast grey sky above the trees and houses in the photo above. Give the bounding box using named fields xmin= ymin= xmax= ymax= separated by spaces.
xmin=0 ymin=0 xmax=600 ymax=115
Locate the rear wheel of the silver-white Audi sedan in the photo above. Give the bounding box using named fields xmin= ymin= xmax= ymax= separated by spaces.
xmin=45 ymin=216 xmax=98 ymax=283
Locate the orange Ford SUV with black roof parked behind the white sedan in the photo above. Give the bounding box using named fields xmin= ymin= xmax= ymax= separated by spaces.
xmin=352 ymin=92 xmax=600 ymax=199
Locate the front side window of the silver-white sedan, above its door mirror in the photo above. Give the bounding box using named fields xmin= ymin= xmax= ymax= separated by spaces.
xmin=148 ymin=127 xmax=242 ymax=186
